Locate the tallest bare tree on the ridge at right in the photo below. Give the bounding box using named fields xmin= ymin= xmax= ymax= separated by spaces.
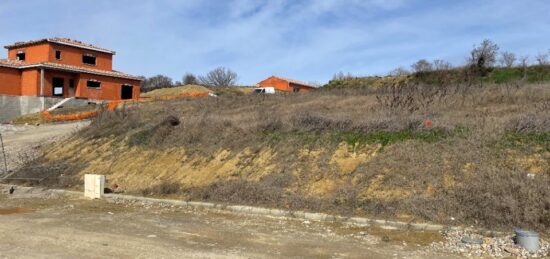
xmin=469 ymin=40 xmax=499 ymax=76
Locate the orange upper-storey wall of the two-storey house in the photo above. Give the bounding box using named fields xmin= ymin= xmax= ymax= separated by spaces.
xmin=8 ymin=43 xmax=113 ymax=71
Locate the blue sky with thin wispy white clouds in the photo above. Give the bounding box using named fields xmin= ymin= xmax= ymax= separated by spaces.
xmin=0 ymin=0 xmax=550 ymax=85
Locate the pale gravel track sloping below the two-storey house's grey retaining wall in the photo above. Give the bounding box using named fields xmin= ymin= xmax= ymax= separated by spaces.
xmin=0 ymin=121 xmax=89 ymax=172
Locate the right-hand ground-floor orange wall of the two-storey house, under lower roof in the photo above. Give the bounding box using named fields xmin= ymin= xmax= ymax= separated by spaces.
xmin=76 ymin=74 xmax=140 ymax=100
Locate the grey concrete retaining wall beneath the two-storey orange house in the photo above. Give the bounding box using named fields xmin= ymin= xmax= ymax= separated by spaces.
xmin=0 ymin=95 xmax=88 ymax=122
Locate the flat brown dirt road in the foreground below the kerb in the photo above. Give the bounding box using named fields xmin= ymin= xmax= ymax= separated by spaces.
xmin=0 ymin=190 xmax=458 ymax=258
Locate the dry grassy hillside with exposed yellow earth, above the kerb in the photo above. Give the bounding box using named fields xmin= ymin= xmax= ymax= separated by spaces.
xmin=12 ymin=84 xmax=550 ymax=230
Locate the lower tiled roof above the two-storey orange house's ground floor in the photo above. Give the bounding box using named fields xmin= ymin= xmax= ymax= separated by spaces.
xmin=0 ymin=59 xmax=141 ymax=81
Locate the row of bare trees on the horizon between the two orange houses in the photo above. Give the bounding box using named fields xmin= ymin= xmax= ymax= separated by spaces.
xmin=141 ymin=67 xmax=239 ymax=92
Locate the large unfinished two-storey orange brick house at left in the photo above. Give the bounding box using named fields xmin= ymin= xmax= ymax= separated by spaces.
xmin=0 ymin=38 xmax=141 ymax=100
